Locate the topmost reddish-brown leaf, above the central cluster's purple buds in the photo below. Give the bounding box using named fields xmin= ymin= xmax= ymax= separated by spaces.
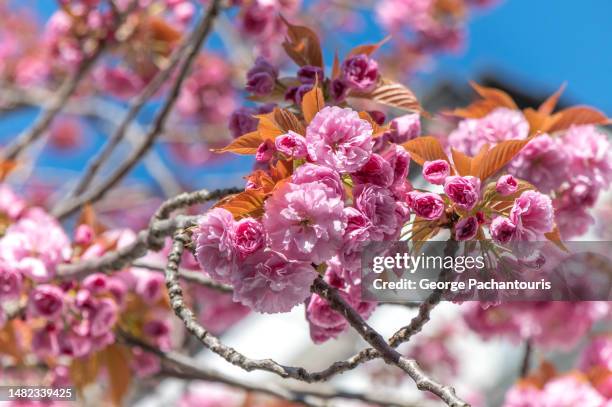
xmin=281 ymin=16 xmax=324 ymax=68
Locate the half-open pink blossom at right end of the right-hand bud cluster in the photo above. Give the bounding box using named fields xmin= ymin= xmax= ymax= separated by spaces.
xmin=510 ymin=191 xmax=554 ymax=241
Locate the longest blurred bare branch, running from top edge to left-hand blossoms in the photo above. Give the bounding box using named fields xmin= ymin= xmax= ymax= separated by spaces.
xmin=54 ymin=0 xmax=225 ymax=219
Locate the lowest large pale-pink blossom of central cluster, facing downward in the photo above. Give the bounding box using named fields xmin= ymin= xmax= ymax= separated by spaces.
xmin=233 ymin=251 xmax=317 ymax=313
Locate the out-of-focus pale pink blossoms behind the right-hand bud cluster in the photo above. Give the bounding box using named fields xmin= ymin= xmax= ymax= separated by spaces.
xmin=448 ymin=107 xmax=612 ymax=239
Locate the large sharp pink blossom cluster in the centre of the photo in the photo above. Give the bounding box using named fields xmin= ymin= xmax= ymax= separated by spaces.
xmin=194 ymin=106 xmax=419 ymax=342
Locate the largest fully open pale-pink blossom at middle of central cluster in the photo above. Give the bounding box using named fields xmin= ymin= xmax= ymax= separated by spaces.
xmin=263 ymin=182 xmax=346 ymax=263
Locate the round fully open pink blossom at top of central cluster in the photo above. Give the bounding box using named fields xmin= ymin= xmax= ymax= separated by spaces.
xmin=306 ymin=106 xmax=373 ymax=173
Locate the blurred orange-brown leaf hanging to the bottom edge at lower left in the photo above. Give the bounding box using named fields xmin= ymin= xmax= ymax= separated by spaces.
xmin=101 ymin=344 xmax=132 ymax=406
